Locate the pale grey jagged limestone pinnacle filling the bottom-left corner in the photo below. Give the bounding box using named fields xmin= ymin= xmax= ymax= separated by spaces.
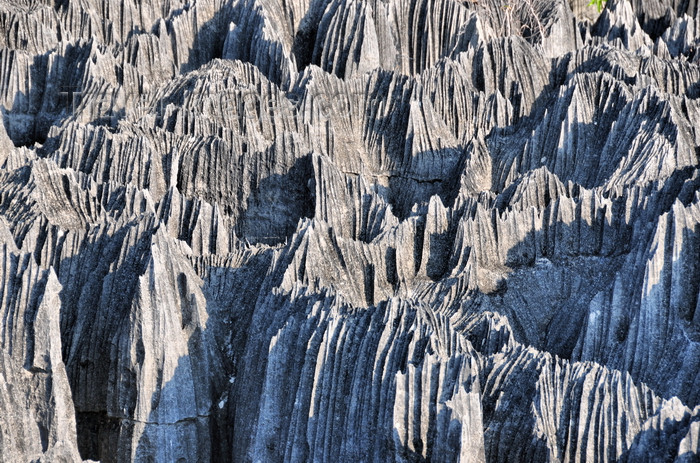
xmin=0 ymin=241 xmax=80 ymax=462
